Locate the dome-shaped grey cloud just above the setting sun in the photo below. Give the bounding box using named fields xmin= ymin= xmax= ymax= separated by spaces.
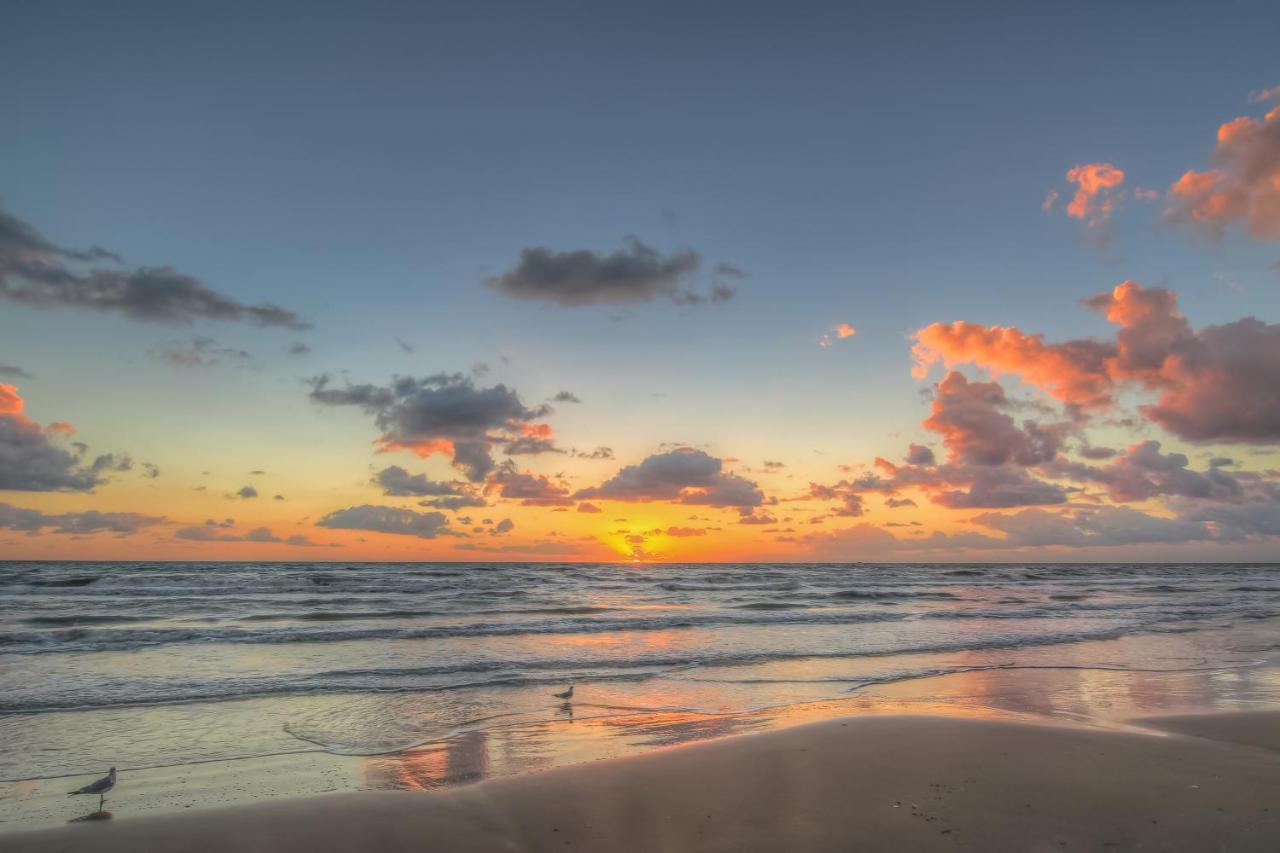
xmin=573 ymin=447 xmax=764 ymax=507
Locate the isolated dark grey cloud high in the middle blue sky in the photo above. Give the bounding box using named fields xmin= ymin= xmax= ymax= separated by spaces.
xmin=486 ymin=237 xmax=736 ymax=307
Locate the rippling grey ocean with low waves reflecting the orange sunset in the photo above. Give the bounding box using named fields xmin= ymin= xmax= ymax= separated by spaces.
xmin=0 ymin=562 xmax=1280 ymax=799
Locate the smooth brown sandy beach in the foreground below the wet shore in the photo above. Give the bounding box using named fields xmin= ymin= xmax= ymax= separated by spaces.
xmin=10 ymin=713 xmax=1280 ymax=853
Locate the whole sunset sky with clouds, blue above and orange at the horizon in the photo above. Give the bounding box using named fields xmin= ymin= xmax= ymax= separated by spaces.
xmin=0 ymin=1 xmax=1280 ymax=562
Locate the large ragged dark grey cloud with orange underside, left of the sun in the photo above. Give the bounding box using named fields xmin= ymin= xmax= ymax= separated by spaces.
xmin=310 ymin=373 xmax=554 ymax=482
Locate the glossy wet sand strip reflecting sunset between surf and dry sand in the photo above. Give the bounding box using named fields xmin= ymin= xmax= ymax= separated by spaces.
xmin=10 ymin=648 xmax=1280 ymax=835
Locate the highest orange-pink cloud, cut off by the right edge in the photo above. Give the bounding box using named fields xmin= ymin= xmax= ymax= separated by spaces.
xmin=1166 ymin=102 xmax=1280 ymax=240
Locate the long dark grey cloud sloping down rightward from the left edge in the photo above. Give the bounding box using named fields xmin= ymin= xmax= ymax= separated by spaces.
xmin=0 ymin=202 xmax=307 ymax=329
